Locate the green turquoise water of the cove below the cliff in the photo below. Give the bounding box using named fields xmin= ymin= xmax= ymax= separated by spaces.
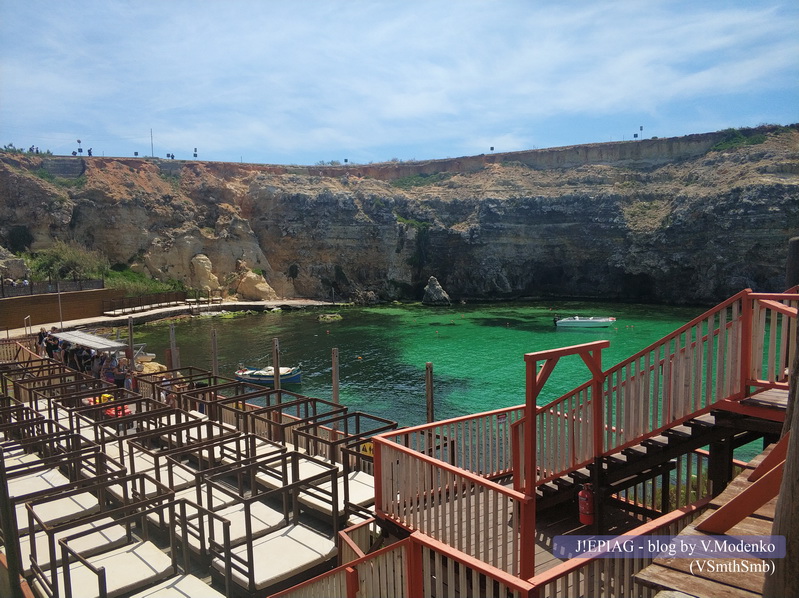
xmin=134 ymin=302 xmax=704 ymax=426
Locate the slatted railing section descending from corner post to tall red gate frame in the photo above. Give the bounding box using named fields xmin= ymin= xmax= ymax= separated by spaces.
xmin=374 ymin=437 xmax=535 ymax=575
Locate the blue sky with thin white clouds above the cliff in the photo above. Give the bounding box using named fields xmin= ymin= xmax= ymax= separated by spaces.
xmin=0 ymin=0 xmax=799 ymax=164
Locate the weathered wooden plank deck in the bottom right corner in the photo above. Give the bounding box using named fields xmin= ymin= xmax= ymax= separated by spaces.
xmin=636 ymin=445 xmax=777 ymax=598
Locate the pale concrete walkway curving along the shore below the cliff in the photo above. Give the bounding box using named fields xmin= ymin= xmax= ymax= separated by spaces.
xmin=6 ymin=299 xmax=342 ymax=338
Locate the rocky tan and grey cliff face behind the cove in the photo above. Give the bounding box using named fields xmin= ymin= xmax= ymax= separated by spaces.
xmin=0 ymin=127 xmax=799 ymax=303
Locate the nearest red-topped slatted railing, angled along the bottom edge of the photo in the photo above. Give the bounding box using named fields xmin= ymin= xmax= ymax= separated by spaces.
xmin=272 ymin=499 xmax=708 ymax=598
